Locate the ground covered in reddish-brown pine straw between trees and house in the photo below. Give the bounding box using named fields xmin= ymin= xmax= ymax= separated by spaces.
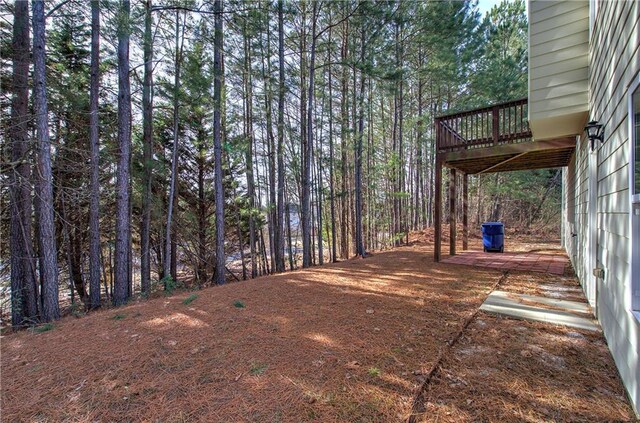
xmin=1 ymin=233 xmax=634 ymax=422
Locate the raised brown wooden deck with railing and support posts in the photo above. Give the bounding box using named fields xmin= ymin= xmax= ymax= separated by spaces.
xmin=434 ymin=98 xmax=576 ymax=261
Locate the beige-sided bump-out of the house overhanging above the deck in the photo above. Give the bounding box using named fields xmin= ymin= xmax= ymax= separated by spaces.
xmin=529 ymin=0 xmax=589 ymax=139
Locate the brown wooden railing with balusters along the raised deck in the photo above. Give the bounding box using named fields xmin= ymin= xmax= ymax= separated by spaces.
xmin=435 ymin=98 xmax=531 ymax=152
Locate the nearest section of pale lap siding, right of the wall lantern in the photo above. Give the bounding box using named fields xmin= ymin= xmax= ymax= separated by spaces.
xmin=588 ymin=1 xmax=640 ymax=412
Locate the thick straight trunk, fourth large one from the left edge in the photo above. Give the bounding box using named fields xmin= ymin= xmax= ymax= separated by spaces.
xmin=113 ymin=0 xmax=131 ymax=306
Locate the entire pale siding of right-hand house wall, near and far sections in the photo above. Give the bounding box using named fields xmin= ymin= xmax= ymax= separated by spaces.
xmin=562 ymin=1 xmax=640 ymax=413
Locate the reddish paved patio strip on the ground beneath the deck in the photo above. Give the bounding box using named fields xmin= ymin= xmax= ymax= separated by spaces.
xmin=442 ymin=251 xmax=569 ymax=275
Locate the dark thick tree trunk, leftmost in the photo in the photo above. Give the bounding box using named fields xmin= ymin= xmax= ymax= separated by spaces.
xmin=9 ymin=1 xmax=38 ymax=326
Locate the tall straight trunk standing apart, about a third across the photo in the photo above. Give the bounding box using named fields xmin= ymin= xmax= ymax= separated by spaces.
xmin=213 ymin=0 xmax=226 ymax=285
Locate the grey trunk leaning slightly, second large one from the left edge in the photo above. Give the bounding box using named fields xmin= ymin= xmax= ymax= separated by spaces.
xmin=33 ymin=1 xmax=60 ymax=322
